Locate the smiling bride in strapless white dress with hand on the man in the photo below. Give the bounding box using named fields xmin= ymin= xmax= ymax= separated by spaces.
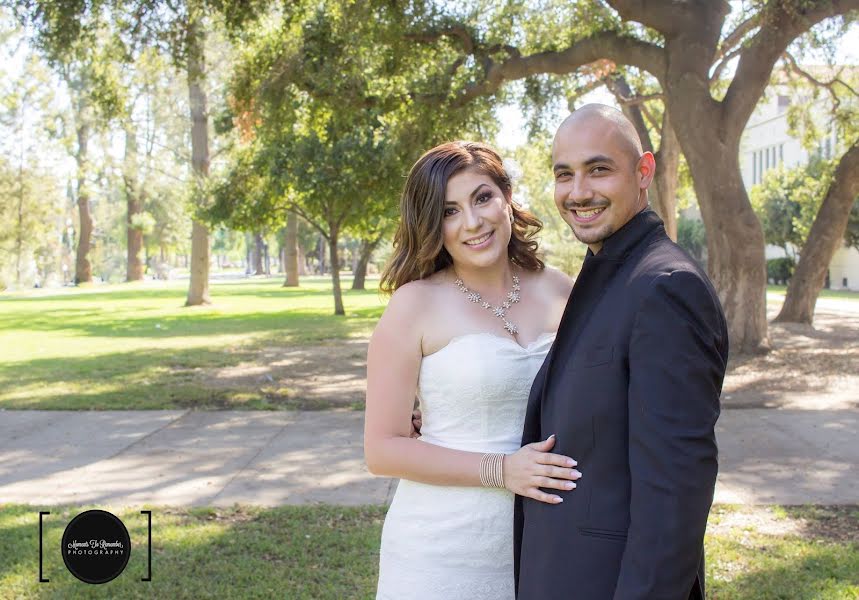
xmin=364 ymin=142 xmax=581 ymax=600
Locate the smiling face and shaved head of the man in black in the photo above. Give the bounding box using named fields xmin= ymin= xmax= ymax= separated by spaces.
xmin=552 ymin=108 xmax=655 ymax=253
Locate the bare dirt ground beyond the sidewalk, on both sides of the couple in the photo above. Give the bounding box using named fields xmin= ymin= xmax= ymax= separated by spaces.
xmin=194 ymin=307 xmax=859 ymax=410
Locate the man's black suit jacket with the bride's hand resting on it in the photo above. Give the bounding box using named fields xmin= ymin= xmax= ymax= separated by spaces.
xmin=514 ymin=209 xmax=728 ymax=600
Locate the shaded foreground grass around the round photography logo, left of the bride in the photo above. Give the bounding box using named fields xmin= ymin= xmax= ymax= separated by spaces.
xmin=0 ymin=506 xmax=384 ymax=600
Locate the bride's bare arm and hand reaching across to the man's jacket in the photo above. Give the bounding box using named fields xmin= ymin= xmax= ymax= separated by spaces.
xmin=364 ymin=285 xmax=580 ymax=503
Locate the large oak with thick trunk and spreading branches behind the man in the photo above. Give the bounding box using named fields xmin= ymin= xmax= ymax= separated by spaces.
xmin=398 ymin=0 xmax=859 ymax=352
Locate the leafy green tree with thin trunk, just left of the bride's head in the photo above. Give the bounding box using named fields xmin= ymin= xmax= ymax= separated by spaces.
xmin=210 ymin=2 xmax=493 ymax=314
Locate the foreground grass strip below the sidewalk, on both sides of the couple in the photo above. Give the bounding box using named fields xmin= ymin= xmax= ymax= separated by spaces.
xmin=0 ymin=505 xmax=859 ymax=600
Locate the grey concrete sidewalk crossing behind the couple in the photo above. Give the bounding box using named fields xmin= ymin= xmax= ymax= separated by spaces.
xmin=0 ymin=409 xmax=859 ymax=506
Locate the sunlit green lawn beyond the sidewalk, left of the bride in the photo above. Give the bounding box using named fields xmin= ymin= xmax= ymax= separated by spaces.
xmin=0 ymin=277 xmax=384 ymax=410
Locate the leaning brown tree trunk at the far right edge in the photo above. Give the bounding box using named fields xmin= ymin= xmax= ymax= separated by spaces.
xmin=775 ymin=140 xmax=859 ymax=325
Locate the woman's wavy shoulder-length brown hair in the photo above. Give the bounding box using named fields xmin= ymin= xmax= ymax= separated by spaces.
xmin=379 ymin=142 xmax=544 ymax=294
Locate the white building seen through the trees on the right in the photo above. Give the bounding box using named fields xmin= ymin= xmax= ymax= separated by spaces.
xmin=740 ymin=95 xmax=859 ymax=291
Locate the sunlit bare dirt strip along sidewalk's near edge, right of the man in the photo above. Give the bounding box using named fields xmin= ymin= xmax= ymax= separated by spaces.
xmin=707 ymin=505 xmax=859 ymax=543
